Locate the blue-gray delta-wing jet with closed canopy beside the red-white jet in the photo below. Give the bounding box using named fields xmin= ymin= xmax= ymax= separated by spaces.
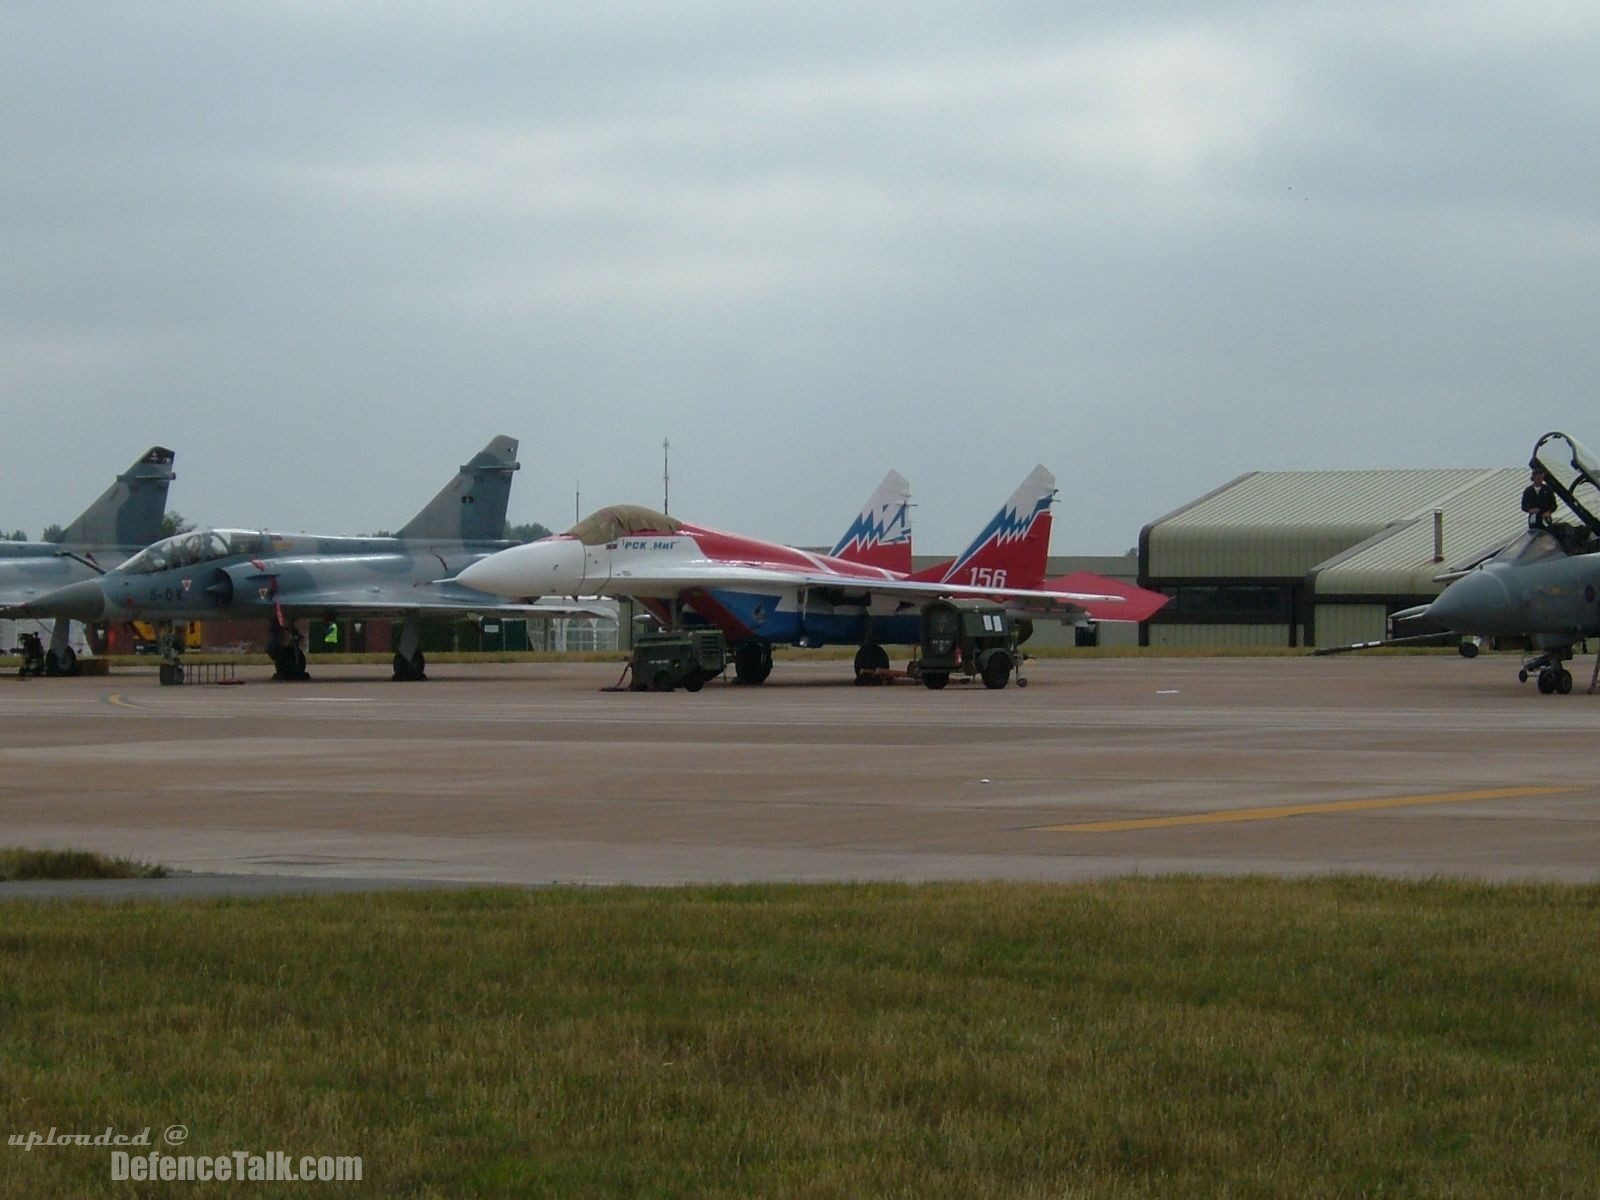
xmin=29 ymin=437 xmax=595 ymax=683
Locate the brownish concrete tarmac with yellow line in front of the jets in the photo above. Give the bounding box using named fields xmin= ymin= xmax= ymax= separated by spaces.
xmin=0 ymin=656 xmax=1600 ymax=896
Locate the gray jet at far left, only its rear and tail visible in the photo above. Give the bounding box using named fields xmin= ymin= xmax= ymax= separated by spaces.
xmin=0 ymin=446 xmax=176 ymax=675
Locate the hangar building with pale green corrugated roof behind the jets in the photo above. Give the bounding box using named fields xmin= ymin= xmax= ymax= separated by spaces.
xmin=1139 ymin=467 xmax=1528 ymax=646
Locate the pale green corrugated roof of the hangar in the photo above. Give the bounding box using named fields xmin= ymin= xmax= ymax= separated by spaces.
xmin=1141 ymin=467 xmax=1526 ymax=592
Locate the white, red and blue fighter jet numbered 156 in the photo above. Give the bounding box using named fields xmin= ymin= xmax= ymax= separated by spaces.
xmin=456 ymin=467 xmax=1166 ymax=683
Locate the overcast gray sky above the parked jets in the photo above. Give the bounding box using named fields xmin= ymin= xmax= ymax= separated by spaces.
xmin=0 ymin=0 xmax=1600 ymax=554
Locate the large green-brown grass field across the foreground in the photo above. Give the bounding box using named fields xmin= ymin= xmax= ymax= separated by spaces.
xmin=0 ymin=880 xmax=1600 ymax=1197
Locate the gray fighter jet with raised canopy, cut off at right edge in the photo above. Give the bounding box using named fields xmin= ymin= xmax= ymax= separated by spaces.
xmin=1394 ymin=432 xmax=1600 ymax=696
